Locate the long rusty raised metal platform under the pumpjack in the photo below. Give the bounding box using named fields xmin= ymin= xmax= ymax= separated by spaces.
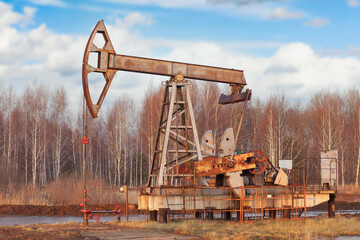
xmin=138 ymin=167 xmax=336 ymax=221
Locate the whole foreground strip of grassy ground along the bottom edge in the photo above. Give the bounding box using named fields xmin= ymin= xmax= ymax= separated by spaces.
xmin=0 ymin=216 xmax=360 ymax=240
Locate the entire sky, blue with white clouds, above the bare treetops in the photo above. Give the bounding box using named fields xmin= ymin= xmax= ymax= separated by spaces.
xmin=0 ymin=0 xmax=360 ymax=116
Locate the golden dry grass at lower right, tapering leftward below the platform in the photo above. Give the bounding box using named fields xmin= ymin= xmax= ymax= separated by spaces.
xmin=120 ymin=217 xmax=360 ymax=239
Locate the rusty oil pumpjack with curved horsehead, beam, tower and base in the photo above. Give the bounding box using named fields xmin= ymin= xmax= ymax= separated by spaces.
xmin=82 ymin=20 xmax=338 ymax=222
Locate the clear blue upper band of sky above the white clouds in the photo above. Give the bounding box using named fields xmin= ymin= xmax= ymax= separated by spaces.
xmin=5 ymin=0 xmax=360 ymax=49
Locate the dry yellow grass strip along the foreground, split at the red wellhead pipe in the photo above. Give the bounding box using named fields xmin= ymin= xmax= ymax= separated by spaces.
xmin=0 ymin=217 xmax=360 ymax=240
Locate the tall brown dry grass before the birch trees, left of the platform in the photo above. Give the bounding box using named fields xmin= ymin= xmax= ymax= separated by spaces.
xmin=0 ymin=178 xmax=138 ymax=206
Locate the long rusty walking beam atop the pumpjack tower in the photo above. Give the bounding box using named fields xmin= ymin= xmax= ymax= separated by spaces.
xmin=109 ymin=54 xmax=246 ymax=85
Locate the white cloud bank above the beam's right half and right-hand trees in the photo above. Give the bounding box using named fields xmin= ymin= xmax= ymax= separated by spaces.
xmin=159 ymin=42 xmax=360 ymax=102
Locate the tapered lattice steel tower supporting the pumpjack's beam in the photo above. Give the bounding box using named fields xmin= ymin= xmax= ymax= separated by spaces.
xmin=147 ymin=80 xmax=202 ymax=187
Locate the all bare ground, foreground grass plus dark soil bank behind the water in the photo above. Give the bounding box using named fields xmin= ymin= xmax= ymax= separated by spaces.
xmin=0 ymin=190 xmax=360 ymax=240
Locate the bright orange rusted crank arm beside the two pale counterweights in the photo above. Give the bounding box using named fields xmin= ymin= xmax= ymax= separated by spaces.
xmin=194 ymin=152 xmax=256 ymax=177
